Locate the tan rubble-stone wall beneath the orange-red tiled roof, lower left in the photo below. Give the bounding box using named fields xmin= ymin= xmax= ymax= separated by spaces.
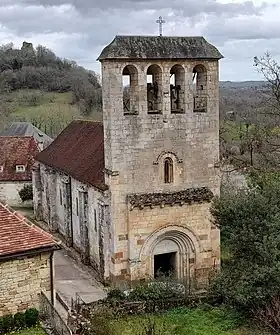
xmin=0 ymin=253 xmax=51 ymax=316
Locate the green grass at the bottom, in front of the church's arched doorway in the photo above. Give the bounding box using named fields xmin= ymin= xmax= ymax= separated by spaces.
xmin=111 ymin=308 xmax=269 ymax=335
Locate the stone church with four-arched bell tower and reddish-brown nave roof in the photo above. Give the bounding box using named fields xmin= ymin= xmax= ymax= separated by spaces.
xmin=33 ymin=36 xmax=223 ymax=288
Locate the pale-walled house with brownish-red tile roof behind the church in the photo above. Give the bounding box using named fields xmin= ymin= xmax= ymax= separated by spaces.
xmin=0 ymin=136 xmax=39 ymax=206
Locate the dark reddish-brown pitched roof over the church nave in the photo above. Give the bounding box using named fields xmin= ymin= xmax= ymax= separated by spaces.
xmin=35 ymin=120 xmax=108 ymax=190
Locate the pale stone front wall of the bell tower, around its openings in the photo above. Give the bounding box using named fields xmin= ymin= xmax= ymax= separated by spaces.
xmin=102 ymin=60 xmax=220 ymax=284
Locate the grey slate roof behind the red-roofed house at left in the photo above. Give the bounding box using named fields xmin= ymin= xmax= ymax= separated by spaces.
xmin=0 ymin=122 xmax=53 ymax=148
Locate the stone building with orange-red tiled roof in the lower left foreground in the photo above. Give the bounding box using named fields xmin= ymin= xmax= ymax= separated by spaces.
xmin=0 ymin=203 xmax=58 ymax=316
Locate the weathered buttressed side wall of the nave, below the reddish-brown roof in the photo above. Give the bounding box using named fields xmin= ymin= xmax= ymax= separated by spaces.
xmin=33 ymin=164 xmax=111 ymax=277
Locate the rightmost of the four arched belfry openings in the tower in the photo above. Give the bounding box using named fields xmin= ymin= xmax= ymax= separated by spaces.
xmin=193 ymin=64 xmax=207 ymax=112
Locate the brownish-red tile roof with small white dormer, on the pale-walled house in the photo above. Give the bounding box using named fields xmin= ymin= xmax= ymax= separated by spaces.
xmin=0 ymin=136 xmax=39 ymax=181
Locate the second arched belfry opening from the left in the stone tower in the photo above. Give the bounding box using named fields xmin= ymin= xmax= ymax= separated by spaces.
xmin=147 ymin=64 xmax=162 ymax=113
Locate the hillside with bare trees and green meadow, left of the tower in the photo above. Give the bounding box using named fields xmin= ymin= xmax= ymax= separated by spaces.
xmin=0 ymin=42 xmax=101 ymax=137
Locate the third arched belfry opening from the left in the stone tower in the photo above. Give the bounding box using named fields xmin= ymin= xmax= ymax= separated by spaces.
xmin=170 ymin=64 xmax=185 ymax=113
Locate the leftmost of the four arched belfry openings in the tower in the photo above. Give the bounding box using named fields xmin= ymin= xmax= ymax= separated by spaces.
xmin=122 ymin=65 xmax=139 ymax=114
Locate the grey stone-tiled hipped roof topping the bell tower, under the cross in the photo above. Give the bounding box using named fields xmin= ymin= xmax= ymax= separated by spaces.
xmin=98 ymin=36 xmax=223 ymax=61
